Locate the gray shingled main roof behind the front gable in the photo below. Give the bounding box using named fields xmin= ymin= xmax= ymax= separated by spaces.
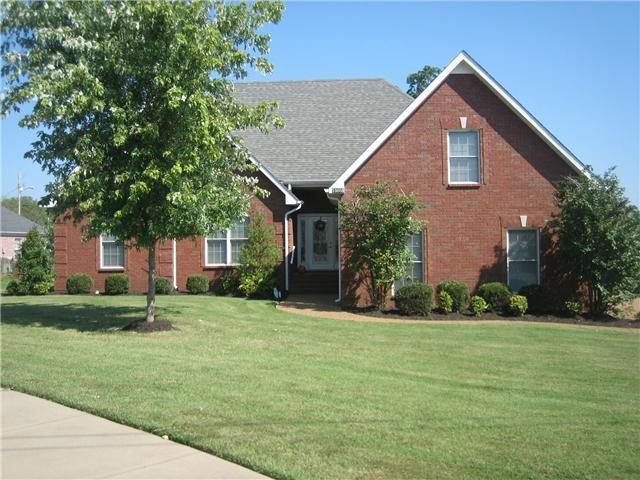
xmin=236 ymin=79 xmax=413 ymax=185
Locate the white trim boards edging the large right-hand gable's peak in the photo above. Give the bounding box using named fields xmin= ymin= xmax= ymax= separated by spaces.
xmin=329 ymin=51 xmax=589 ymax=193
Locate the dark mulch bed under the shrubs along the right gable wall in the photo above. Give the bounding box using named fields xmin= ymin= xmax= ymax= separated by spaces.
xmin=348 ymin=308 xmax=640 ymax=328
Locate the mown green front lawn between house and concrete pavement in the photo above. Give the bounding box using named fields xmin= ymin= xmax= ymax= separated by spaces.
xmin=1 ymin=296 xmax=640 ymax=479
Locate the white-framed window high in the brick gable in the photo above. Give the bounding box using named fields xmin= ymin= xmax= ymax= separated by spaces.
xmin=449 ymin=130 xmax=480 ymax=184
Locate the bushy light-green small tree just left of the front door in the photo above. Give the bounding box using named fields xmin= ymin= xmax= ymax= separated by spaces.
xmin=238 ymin=212 xmax=281 ymax=297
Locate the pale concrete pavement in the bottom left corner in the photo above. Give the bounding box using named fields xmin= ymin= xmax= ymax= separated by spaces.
xmin=0 ymin=390 xmax=267 ymax=479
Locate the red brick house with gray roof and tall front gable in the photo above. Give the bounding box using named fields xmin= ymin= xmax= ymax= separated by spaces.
xmin=55 ymin=52 xmax=585 ymax=305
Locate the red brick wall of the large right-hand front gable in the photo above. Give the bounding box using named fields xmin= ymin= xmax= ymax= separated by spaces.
xmin=343 ymin=75 xmax=572 ymax=305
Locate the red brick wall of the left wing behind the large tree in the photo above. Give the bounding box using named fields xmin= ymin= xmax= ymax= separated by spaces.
xmin=55 ymin=174 xmax=293 ymax=293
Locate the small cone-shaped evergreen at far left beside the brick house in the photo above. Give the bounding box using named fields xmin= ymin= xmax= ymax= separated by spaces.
xmin=15 ymin=228 xmax=56 ymax=295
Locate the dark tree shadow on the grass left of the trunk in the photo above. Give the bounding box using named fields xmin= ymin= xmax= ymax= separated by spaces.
xmin=2 ymin=302 xmax=182 ymax=332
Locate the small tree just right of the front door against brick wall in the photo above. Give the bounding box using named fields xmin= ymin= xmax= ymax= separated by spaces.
xmin=338 ymin=182 xmax=422 ymax=309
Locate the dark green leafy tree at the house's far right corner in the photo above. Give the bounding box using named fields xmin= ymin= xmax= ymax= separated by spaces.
xmin=550 ymin=169 xmax=640 ymax=314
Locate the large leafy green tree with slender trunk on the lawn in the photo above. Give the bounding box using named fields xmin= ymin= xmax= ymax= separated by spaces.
xmin=1 ymin=0 xmax=284 ymax=322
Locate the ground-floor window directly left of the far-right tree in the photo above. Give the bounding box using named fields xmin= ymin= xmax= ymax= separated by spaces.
xmin=507 ymin=229 xmax=540 ymax=292
